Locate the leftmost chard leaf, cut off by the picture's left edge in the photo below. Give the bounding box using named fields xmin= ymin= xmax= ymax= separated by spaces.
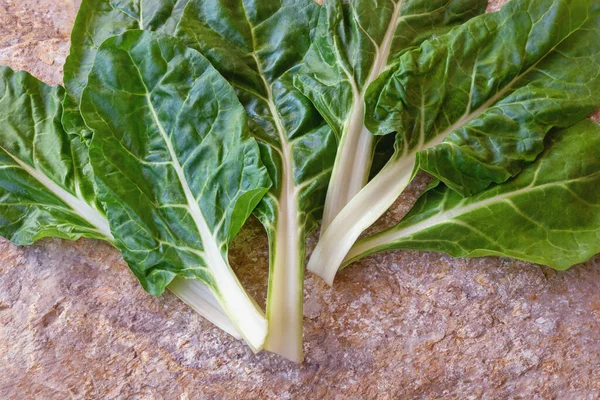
xmin=0 ymin=67 xmax=112 ymax=244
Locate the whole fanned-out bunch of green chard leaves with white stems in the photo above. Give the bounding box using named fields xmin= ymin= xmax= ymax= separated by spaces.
xmin=0 ymin=0 xmax=600 ymax=362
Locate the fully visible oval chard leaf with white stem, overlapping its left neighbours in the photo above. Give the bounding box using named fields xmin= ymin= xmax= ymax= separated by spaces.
xmin=81 ymin=31 xmax=270 ymax=350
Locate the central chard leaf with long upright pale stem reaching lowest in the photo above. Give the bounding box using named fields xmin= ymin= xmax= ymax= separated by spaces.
xmin=176 ymin=0 xmax=336 ymax=362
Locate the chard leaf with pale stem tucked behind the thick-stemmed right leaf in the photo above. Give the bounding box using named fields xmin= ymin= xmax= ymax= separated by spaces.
xmin=296 ymin=0 xmax=487 ymax=232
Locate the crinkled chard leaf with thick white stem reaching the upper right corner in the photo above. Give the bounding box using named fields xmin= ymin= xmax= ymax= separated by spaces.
xmin=308 ymin=0 xmax=600 ymax=283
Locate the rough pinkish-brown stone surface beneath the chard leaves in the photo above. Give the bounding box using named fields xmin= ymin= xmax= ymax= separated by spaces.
xmin=0 ymin=0 xmax=600 ymax=400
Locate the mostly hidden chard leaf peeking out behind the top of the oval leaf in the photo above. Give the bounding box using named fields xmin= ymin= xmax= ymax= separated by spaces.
xmin=62 ymin=0 xmax=188 ymax=137
